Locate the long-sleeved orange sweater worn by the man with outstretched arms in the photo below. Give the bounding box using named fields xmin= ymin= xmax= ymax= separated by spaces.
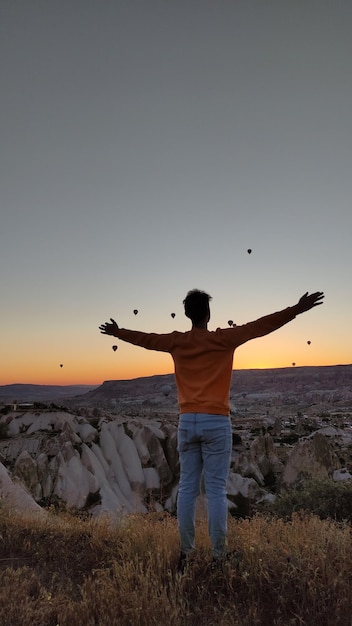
xmin=115 ymin=307 xmax=297 ymax=415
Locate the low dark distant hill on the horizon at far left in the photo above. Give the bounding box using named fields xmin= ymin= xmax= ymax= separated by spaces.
xmin=0 ymin=383 xmax=97 ymax=402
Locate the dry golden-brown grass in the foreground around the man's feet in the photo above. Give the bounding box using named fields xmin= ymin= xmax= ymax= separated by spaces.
xmin=0 ymin=508 xmax=352 ymax=626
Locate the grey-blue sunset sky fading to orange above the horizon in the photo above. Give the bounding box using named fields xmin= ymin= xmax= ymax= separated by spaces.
xmin=0 ymin=0 xmax=352 ymax=385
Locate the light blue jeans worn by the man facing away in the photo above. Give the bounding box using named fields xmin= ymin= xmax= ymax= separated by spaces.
xmin=177 ymin=413 xmax=232 ymax=558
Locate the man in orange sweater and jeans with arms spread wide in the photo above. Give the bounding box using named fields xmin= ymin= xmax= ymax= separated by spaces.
xmin=99 ymin=289 xmax=324 ymax=570
